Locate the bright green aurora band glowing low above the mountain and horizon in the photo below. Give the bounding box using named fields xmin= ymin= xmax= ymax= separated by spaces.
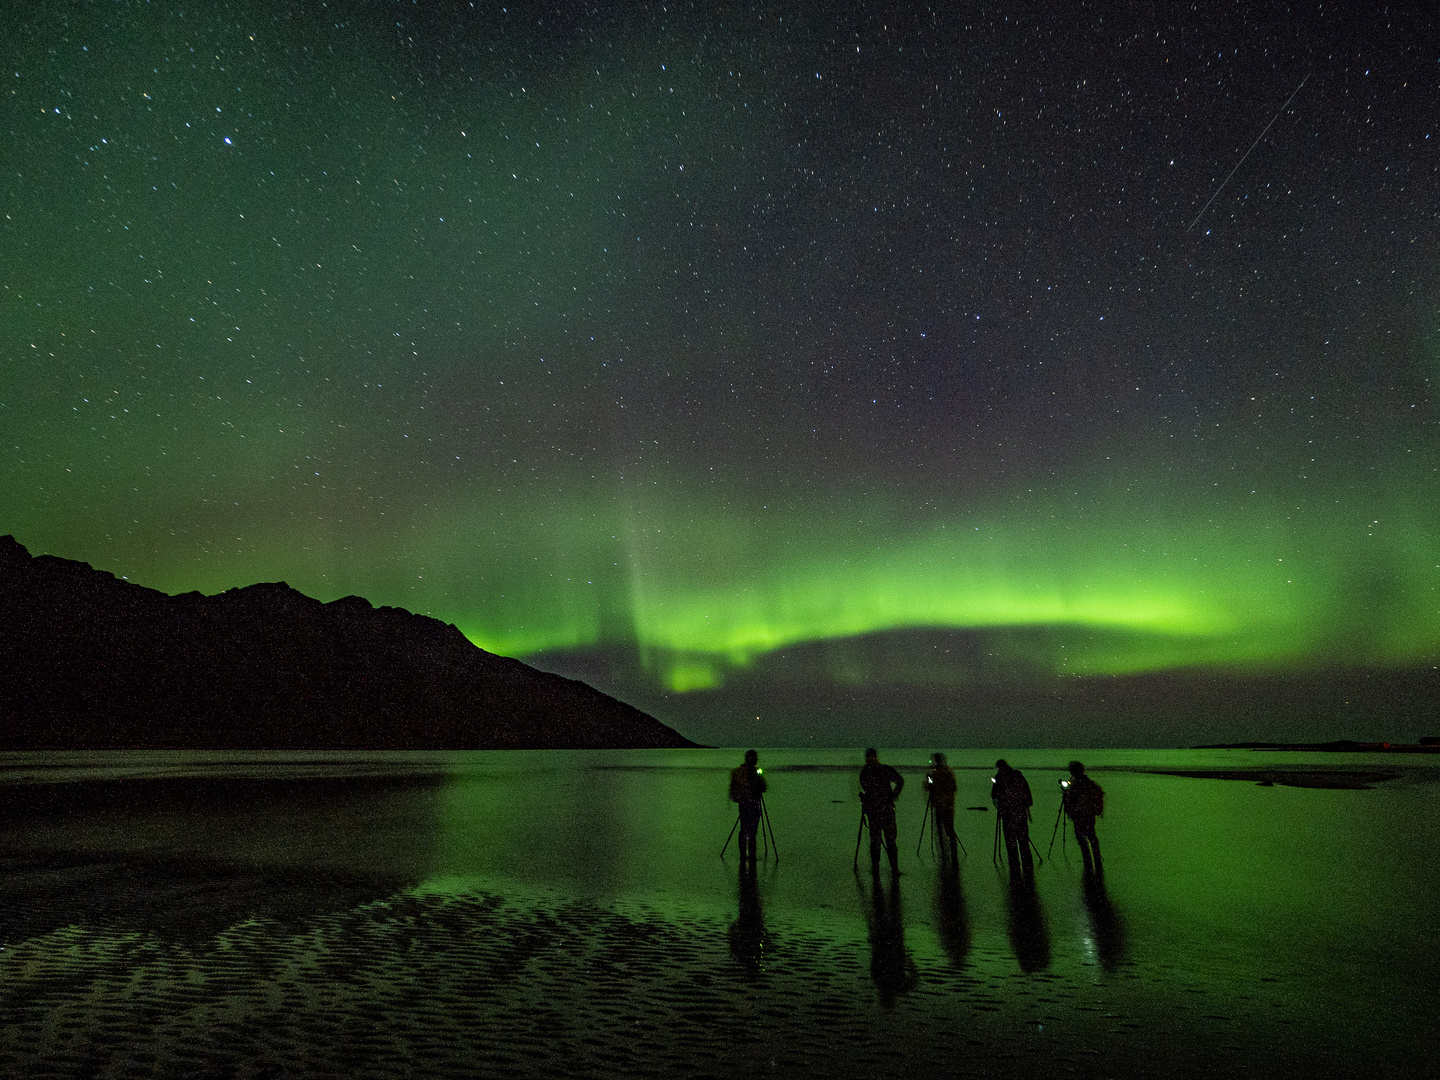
xmin=5 ymin=457 xmax=1440 ymax=691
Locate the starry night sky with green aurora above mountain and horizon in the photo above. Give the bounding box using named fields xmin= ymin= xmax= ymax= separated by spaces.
xmin=0 ymin=1 xmax=1440 ymax=744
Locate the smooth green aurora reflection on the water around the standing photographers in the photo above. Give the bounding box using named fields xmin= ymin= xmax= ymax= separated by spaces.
xmin=423 ymin=750 xmax=1440 ymax=1002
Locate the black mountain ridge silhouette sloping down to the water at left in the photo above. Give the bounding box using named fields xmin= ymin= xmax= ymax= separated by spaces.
xmin=0 ymin=536 xmax=694 ymax=750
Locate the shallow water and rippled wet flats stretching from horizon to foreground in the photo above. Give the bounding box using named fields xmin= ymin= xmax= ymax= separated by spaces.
xmin=0 ymin=750 xmax=1440 ymax=1076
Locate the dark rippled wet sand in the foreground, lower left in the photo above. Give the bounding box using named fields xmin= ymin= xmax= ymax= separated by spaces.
xmin=0 ymin=860 xmax=1385 ymax=1079
